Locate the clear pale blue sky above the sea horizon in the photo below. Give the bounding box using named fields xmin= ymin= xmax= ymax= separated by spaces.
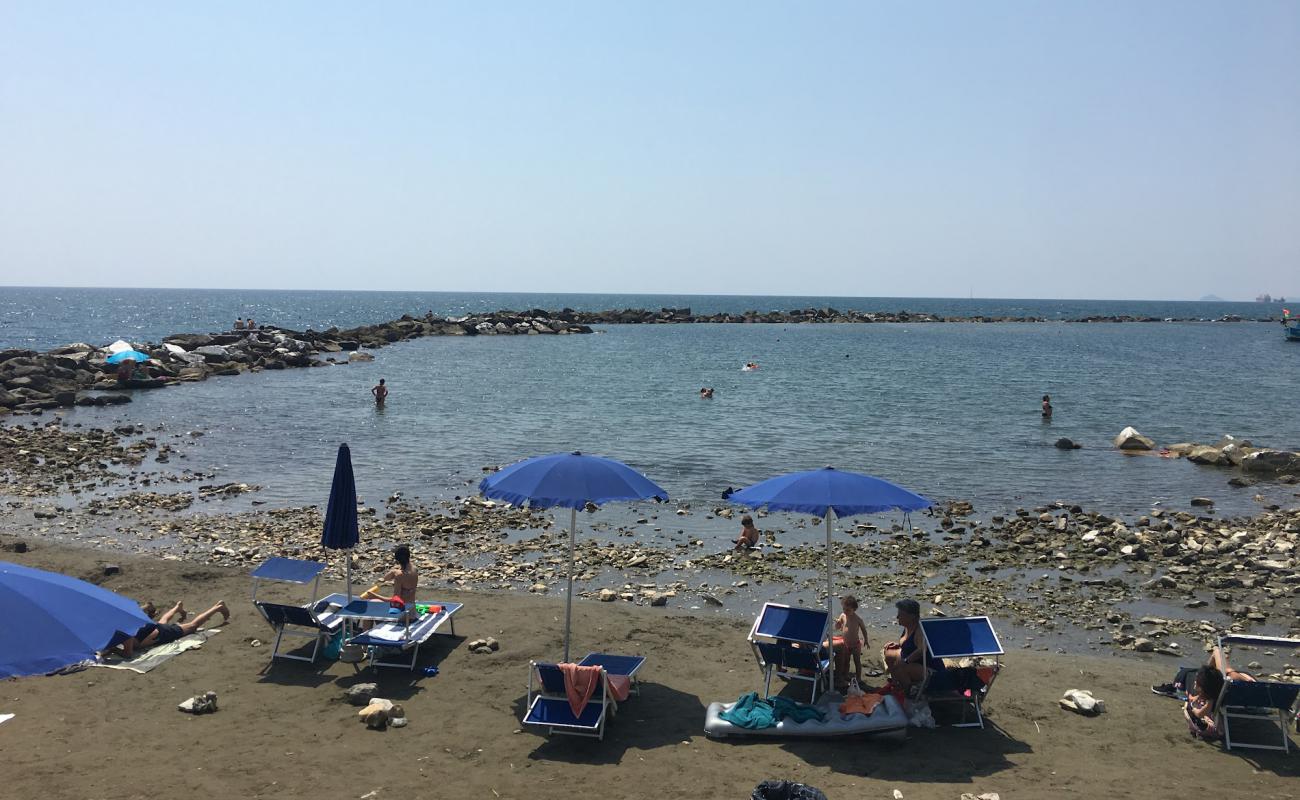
xmin=0 ymin=0 xmax=1300 ymax=299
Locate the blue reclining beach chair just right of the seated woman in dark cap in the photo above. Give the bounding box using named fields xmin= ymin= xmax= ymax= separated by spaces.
xmin=920 ymin=617 xmax=1006 ymax=727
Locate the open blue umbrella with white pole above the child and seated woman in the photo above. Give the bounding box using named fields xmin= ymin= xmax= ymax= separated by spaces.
xmin=728 ymin=467 xmax=935 ymax=621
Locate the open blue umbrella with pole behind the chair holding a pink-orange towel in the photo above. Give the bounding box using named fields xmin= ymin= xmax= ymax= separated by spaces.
xmin=478 ymin=453 xmax=668 ymax=662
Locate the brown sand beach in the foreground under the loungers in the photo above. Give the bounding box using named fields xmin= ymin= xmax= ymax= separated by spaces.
xmin=0 ymin=537 xmax=1300 ymax=800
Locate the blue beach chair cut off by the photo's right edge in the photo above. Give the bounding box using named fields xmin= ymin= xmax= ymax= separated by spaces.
xmin=1216 ymin=635 xmax=1300 ymax=752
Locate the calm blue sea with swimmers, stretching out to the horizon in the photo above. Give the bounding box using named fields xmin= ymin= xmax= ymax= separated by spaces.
xmin=0 ymin=287 xmax=1300 ymax=526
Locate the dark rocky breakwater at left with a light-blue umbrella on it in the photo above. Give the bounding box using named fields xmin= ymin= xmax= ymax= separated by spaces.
xmin=0 ymin=310 xmax=592 ymax=414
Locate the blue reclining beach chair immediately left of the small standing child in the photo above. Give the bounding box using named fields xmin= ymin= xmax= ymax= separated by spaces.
xmin=749 ymin=602 xmax=831 ymax=702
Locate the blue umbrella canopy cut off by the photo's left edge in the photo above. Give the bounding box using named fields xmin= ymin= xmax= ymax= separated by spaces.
xmin=0 ymin=562 xmax=150 ymax=678
